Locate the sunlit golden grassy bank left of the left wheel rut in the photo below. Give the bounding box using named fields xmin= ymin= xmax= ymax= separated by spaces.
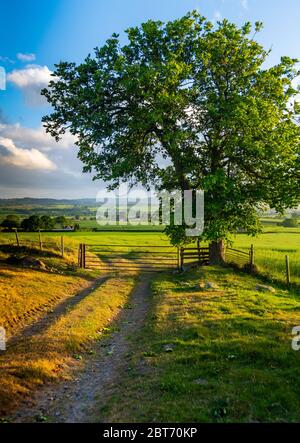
xmin=0 ymin=247 xmax=97 ymax=338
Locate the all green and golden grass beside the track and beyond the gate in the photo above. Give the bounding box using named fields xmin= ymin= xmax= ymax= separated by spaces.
xmin=0 ymin=226 xmax=300 ymax=422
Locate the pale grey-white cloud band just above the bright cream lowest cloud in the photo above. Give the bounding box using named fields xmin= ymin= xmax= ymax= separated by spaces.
xmin=0 ymin=123 xmax=76 ymax=151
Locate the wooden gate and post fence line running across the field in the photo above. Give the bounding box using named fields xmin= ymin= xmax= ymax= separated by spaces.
xmin=0 ymin=230 xmax=300 ymax=285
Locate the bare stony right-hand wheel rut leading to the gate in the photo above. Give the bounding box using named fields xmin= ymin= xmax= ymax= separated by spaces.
xmin=14 ymin=274 xmax=152 ymax=423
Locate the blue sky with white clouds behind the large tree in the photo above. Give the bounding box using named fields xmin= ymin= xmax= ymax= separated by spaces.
xmin=0 ymin=0 xmax=300 ymax=198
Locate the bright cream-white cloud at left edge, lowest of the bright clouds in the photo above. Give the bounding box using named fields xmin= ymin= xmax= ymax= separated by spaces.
xmin=0 ymin=137 xmax=56 ymax=171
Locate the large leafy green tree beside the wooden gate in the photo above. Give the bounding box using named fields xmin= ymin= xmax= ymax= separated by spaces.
xmin=43 ymin=12 xmax=300 ymax=260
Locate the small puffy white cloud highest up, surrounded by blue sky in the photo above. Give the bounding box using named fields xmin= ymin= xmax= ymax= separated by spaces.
xmin=7 ymin=65 xmax=54 ymax=105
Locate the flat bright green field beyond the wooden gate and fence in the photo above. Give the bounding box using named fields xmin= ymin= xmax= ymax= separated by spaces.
xmin=0 ymin=225 xmax=300 ymax=284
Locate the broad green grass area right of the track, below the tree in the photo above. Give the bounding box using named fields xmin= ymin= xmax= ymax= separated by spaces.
xmin=101 ymin=268 xmax=300 ymax=422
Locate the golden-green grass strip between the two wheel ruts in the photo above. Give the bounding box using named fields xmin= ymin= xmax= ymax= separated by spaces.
xmin=0 ymin=277 xmax=135 ymax=417
